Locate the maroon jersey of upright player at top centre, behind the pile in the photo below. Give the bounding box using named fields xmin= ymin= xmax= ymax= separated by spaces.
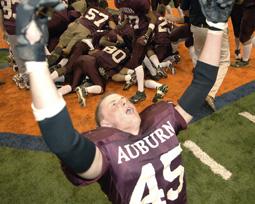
xmin=115 ymin=0 xmax=150 ymax=35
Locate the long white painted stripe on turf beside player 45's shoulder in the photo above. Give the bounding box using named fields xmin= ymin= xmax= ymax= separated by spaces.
xmin=183 ymin=140 xmax=232 ymax=180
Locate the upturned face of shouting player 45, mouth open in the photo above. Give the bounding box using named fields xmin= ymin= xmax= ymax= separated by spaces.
xmin=101 ymin=94 xmax=141 ymax=135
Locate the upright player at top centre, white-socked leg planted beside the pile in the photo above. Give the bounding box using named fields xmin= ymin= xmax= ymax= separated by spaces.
xmin=115 ymin=0 xmax=160 ymax=103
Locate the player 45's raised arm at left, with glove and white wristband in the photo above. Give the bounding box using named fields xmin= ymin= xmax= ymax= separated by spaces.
xmin=16 ymin=0 xmax=102 ymax=179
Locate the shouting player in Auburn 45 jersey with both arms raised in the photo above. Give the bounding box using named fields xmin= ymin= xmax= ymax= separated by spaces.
xmin=17 ymin=0 xmax=234 ymax=204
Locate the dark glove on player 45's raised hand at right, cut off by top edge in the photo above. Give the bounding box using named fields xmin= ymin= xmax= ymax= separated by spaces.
xmin=199 ymin=0 xmax=235 ymax=23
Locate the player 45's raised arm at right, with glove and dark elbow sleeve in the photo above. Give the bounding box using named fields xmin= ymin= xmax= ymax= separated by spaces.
xmin=176 ymin=0 xmax=234 ymax=123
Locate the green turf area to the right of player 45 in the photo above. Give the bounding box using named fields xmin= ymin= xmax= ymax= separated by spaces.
xmin=180 ymin=93 xmax=255 ymax=204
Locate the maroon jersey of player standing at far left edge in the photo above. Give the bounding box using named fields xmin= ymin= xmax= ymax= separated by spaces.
xmin=0 ymin=0 xmax=20 ymax=35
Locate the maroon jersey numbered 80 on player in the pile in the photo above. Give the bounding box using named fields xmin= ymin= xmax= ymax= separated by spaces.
xmin=95 ymin=46 xmax=129 ymax=71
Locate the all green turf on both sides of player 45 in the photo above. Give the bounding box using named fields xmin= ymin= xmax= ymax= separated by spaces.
xmin=0 ymin=93 xmax=255 ymax=204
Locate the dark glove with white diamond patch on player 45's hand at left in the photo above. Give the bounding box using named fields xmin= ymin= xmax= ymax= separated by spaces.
xmin=16 ymin=0 xmax=64 ymax=62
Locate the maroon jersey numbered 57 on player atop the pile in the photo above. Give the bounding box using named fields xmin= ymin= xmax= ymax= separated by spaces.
xmin=79 ymin=7 xmax=112 ymax=33
